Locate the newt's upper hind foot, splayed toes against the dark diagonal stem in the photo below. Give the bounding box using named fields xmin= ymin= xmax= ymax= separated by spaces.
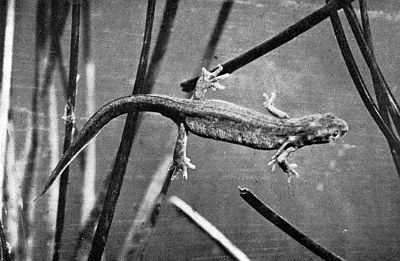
xmin=192 ymin=65 xmax=229 ymax=100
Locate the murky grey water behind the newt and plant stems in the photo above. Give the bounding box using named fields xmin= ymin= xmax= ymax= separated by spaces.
xmin=8 ymin=0 xmax=400 ymax=260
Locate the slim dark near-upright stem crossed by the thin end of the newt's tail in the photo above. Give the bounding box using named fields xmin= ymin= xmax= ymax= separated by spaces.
xmin=53 ymin=0 xmax=81 ymax=260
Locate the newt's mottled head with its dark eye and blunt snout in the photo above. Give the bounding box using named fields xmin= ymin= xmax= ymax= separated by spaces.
xmin=296 ymin=113 xmax=349 ymax=145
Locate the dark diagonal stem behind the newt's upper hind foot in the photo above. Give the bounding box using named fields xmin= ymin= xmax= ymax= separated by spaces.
xmin=181 ymin=0 xmax=354 ymax=92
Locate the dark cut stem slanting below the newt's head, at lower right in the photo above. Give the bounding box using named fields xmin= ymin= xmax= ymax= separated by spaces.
xmin=239 ymin=187 xmax=344 ymax=261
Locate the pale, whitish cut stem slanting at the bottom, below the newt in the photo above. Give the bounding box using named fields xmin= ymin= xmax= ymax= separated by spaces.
xmin=169 ymin=196 xmax=250 ymax=261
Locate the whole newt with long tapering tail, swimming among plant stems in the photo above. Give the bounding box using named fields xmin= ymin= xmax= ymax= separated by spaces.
xmin=39 ymin=66 xmax=348 ymax=197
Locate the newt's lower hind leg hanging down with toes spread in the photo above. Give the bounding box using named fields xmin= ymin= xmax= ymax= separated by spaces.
xmin=170 ymin=123 xmax=196 ymax=180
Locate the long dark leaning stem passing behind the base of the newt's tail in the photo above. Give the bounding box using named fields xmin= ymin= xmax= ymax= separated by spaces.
xmin=88 ymin=0 xmax=156 ymax=261
